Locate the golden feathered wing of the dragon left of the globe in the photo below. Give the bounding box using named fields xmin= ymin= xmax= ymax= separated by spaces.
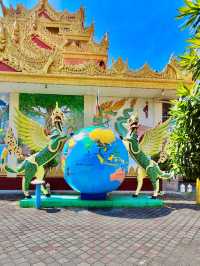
xmin=15 ymin=110 xmax=49 ymax=152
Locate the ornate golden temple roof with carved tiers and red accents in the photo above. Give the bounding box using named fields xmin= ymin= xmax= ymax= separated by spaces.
xmin=0 ymin=0 xmax=191 ymax=87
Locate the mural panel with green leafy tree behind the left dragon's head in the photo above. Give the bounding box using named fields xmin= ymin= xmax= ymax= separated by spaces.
xmin=19 ymin=93 xmax=84 ymax=176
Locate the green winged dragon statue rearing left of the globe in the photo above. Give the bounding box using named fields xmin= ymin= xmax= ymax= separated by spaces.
xmin=2 ymin=103 xmax=68 ymax=198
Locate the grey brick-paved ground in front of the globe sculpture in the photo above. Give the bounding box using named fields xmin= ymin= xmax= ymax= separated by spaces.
xmin=0 ymin=196 xmax=200 ymax=266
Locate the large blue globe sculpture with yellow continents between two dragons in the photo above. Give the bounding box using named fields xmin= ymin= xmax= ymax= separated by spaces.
xmin=62 ymin=126 xmax=129 ymax=200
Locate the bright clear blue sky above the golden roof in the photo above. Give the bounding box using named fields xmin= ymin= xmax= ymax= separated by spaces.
xmin=4 ymin=0 xmax=188 ymax=70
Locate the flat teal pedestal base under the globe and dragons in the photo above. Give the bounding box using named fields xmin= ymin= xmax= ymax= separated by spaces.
xmin=19 ymin=195 xmax=164 ymax=208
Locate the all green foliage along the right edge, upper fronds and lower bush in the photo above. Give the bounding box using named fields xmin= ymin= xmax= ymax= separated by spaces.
xmin=169 ymin=0 xmax=200 ymax=180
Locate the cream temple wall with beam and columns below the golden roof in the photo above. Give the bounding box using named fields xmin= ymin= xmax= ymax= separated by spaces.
xmin=0 ymin=83 xmax=172 ymax=177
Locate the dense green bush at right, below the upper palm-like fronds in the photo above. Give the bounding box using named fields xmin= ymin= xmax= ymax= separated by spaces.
xmin=169 ymin=86 xmax=200 ymax=180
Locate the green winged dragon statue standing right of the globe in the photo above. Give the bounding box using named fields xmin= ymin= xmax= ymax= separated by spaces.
xmin=115 ymin=108 xmax=173 ymax=198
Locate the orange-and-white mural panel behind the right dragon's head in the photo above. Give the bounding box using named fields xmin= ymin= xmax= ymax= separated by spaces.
xmin=93 ymin=97 xmax=162 ymax=177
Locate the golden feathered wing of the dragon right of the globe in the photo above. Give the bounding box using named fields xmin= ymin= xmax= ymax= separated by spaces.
xmin=140 ymin=119 xmax=171 ymax=156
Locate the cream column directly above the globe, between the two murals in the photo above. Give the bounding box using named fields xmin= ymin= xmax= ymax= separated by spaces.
xmin=84 ymin=95 xmax=96 ymax=127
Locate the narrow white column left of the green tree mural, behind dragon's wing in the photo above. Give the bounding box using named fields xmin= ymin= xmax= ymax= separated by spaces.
xmin=7 ymin=92 xmax=19 ymax=177
